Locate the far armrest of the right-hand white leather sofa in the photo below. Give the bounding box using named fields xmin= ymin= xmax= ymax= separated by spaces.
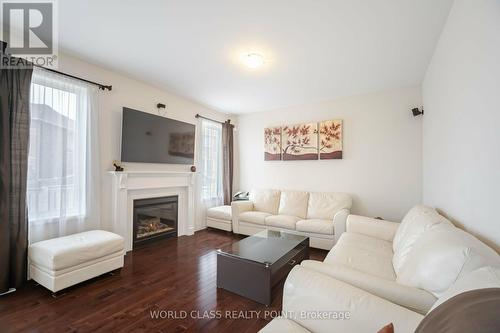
xmin=347 ymin=215 xmax=400 ymax=242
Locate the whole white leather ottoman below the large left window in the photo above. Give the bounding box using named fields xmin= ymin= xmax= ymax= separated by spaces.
xmin=28 ymin=230 xmax=125 ymax=292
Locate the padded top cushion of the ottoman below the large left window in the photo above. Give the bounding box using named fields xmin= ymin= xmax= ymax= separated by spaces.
xmin=28 ymin=230 xmax=124 ymax=271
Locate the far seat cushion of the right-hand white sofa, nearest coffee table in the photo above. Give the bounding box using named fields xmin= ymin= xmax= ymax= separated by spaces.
xmin=324 ymin=232 xmax=396 ymax=281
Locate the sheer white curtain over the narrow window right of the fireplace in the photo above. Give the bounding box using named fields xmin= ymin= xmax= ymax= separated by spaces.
xmin=196 ymin=118 xmax=224 ymax=228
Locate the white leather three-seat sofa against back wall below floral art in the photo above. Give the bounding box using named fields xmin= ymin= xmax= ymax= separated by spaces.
xmin=231 ymin=190 xmax=352 ymax=250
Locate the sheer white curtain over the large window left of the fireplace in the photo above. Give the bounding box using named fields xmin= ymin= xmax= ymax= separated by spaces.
xmin=27 ymin=68 xmax=101 ymax=243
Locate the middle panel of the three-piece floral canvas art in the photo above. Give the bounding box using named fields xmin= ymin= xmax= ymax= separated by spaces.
xmin=282 ymin=123 xmax=318 ymax=161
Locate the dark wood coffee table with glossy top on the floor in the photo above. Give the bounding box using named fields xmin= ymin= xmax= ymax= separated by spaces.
xmin=217 ymin=230 xmax=309 ymax=306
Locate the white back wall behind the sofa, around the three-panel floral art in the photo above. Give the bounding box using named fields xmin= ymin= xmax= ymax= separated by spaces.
xmin=238 ymin=87 xmax=422 ymax=221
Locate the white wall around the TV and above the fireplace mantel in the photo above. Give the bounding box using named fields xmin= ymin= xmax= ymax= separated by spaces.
xmin=59 ymin=54 xmax=232 ymax=228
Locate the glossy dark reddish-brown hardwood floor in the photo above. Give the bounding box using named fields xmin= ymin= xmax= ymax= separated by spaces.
xmin=0 ymin=230 xmax=327 ymax=333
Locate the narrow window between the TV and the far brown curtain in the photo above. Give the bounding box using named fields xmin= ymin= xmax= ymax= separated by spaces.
xmin=201 ymin=120 xmax=222 ymax=201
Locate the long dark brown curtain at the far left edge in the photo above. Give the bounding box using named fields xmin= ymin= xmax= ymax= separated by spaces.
xmin=0 ymin=56 xmax=33 ymax=293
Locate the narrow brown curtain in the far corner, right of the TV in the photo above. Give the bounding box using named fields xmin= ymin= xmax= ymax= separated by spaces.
xmin=222 ymin=120 xmax=234 ymax=205
